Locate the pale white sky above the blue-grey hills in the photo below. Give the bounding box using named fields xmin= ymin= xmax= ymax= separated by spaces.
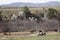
xmin=0 ymin=0 xmax=60 ymax=5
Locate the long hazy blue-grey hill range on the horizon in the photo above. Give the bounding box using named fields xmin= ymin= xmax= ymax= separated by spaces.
xmin=0 ymin=1 xmax=60 ymax=7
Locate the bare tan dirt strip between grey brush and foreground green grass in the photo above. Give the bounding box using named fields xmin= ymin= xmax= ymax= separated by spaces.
xmin=0 ymin=32 xmax=60 ymax=38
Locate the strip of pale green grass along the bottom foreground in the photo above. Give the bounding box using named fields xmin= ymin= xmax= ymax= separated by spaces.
xmin=0 ymin=31 xmax=60 ymax=40
